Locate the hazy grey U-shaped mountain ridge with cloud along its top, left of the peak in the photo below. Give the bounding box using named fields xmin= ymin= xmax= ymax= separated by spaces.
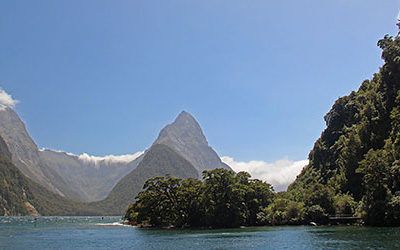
xmin=0 ymin=108 xmax=141 ymax=202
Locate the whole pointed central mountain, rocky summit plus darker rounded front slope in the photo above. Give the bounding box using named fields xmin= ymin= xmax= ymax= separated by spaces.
xmin=95 ymin=112 xmax=230 ymax=215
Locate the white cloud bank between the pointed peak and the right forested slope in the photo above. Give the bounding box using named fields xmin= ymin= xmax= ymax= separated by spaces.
xmin=221 ymin=156 xmax=308 ymax=191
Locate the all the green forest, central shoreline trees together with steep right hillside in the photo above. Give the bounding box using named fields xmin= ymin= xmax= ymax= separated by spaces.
xmin=125 ymin=29 xmax=400 ymax=228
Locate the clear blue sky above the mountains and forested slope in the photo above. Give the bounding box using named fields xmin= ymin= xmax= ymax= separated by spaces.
xmin=0 ymin=0 xmax=400 ymax=189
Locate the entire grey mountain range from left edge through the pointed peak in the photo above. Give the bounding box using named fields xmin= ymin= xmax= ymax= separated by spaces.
xmin=0 ymin=108 xmax=230 ymax=215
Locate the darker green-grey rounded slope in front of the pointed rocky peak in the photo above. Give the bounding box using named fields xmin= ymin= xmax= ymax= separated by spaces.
xmin=92 ymin=144 xmax=198 ymax=215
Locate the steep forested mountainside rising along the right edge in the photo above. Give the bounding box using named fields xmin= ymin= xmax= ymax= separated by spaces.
xmin=288 ymin=31 xmax=400 ymax=226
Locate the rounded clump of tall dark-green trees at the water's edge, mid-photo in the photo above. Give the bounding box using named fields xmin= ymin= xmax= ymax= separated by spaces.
xmin=125 ymin=169 xmax=274 ymax=228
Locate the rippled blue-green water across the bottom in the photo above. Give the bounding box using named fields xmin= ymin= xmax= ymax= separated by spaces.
xmin=0 ymin=217 xmax=400 ymax=250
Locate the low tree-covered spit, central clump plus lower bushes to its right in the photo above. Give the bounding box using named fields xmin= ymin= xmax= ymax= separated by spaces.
xmin=125 ymin=169 xmax=354 ymax=228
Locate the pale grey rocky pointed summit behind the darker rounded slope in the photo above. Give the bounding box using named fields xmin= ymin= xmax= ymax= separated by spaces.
xmin=154 ymin=111 xmax=231 ymax=176
